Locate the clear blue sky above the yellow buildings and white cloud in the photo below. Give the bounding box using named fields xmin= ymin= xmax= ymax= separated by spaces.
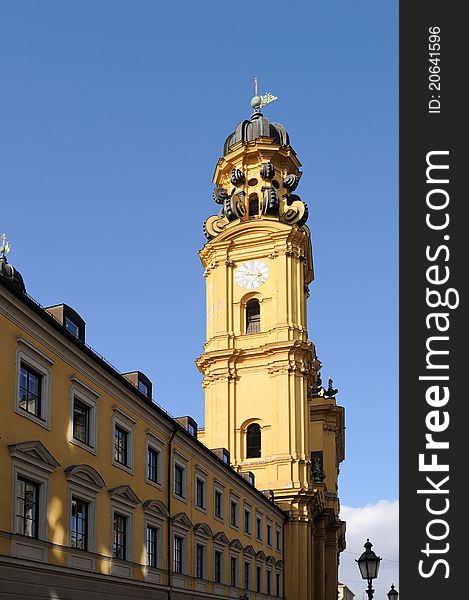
xmin=0 ymin=0 xmax=398 ymax=552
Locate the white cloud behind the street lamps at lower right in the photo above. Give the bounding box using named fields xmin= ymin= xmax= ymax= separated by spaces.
xmin=339 ymin=500 xmax=399 ymax=600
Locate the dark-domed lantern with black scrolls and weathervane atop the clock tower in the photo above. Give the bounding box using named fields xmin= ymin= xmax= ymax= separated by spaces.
xmin=204 ymin=90 xmax=308 ymax=240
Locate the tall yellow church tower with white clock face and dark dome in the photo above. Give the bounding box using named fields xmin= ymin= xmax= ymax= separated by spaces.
xmin=197 ymin=95 xmax=345 ymax=600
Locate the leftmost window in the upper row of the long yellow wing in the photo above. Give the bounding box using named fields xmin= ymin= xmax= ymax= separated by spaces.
xmin=15 ymin=336 xmax=54 ymax=429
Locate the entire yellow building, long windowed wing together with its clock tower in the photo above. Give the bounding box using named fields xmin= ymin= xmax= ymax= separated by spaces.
xmin=0 ymin=98 xmax=345 ymax=600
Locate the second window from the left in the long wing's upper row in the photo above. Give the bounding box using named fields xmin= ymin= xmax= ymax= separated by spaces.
xmin=70 ymin=376 xmax=99 ymax=454
